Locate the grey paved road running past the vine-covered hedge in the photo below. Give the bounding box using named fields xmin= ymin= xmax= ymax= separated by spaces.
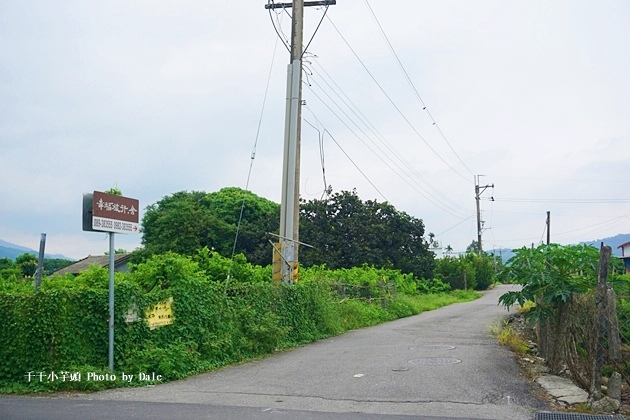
xmin=0 ymin=286 xmax=547 ymax=420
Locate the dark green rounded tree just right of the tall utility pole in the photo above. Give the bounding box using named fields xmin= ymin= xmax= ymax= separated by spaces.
xmin=300 ymin=191 xmax=434 ymax=278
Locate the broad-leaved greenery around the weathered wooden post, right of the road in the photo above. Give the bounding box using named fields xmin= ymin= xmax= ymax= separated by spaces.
xmin=499 ymin=244 xmax=630 ymax=374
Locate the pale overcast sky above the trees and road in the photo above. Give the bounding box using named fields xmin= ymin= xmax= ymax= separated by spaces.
xmin=0 ymin=0 xmax=630 ymax=259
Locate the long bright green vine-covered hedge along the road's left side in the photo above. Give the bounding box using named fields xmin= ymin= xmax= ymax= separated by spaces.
xmin=0 ymin=248 xmax=478 ymax=392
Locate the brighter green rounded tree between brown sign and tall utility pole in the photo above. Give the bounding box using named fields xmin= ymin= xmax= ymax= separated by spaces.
xmin=142 ymin=187 xmax=280 ymax=265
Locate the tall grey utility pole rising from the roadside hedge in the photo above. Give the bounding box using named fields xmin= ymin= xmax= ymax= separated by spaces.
xmin=265 ymin=0 xmax=336 ymax=283
